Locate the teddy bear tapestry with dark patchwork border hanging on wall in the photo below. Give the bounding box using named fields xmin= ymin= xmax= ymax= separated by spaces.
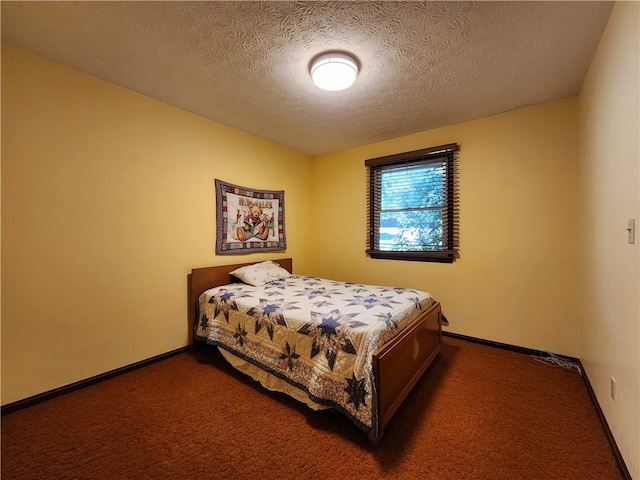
xmin=215 ymin=179 xmax=287 ymax=254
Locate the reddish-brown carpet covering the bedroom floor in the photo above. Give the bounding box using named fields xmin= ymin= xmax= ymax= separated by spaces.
xmin=1 ymin=337 xmax=622 ymax=480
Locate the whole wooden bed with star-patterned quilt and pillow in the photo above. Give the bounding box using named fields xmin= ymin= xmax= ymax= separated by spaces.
xmin=188 ymin=258 xmax=442 ymax=445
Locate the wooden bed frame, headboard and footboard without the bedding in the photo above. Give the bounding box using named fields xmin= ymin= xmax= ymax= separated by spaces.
xmin=188 ymin=258 xmax=442 ymax=444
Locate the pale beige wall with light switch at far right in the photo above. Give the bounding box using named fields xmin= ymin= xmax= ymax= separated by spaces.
xmin=580 ymin=2 xmax=640 ymax=479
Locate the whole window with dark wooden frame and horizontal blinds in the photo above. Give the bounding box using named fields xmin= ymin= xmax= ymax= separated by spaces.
xmin=365 ymin=143 xmax=458 ymax=263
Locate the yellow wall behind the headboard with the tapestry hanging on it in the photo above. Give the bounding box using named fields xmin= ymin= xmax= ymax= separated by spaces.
xmin=2 ymin=45 xmax=311 ymax=404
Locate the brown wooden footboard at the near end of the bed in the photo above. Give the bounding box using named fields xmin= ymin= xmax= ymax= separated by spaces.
xmin=373 ymin=303 xmax=442 ymax=441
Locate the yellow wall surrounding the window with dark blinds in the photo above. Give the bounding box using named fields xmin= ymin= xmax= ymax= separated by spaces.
xmin=312 ymin=98 xmax=581 ymax=356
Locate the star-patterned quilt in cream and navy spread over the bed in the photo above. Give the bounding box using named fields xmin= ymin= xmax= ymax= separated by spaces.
xmin=195 ymin=275 xmax=435 ymax=439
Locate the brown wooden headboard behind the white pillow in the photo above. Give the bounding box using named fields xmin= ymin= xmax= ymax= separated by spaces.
xmin=187 ymin=258 xmax=293 ymax=345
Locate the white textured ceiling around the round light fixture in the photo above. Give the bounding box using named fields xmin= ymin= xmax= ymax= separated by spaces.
xmin=1 ymin=1 xmax=613 ymax=155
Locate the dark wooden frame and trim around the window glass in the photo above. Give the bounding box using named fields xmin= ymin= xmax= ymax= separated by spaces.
xmin=365 ymin=143 xmax=459 ymax=263
